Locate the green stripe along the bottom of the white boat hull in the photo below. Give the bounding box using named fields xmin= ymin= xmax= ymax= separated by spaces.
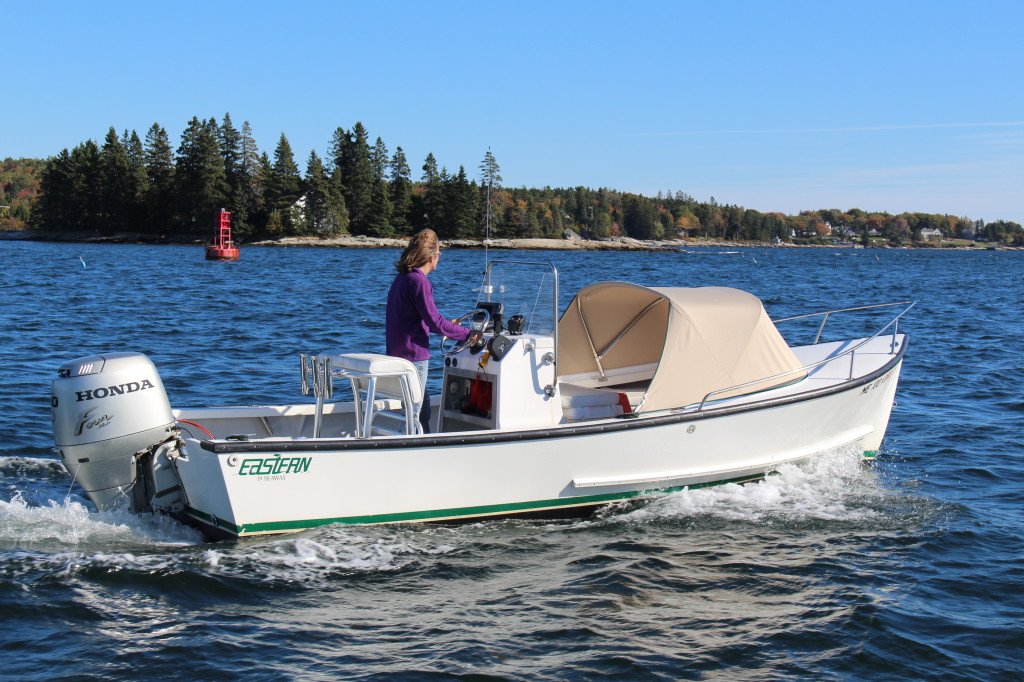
xmin=185 ymin=475 xmax=764 ymax=537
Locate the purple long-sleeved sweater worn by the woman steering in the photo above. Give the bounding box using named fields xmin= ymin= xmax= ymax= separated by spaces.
xmin=384 ymin=267 xmax=469 ymax=363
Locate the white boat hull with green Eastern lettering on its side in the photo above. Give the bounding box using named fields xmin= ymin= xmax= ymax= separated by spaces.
xmin=177 ymin=352 xmax=902 ymax=537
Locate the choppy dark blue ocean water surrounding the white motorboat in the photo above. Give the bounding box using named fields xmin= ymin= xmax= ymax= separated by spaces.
xmin=0 ymin=242 xmax=1024 ymax=680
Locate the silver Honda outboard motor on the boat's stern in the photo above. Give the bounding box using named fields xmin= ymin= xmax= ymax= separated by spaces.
xmin=50 ymin=352 xmax=176 ymax=512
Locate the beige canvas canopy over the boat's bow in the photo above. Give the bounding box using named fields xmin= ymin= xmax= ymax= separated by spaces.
xmin=558 ymin=282 xmax=805 ymax=412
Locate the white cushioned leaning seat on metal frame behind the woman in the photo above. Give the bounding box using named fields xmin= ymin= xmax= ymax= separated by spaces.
xmin=322 ymin=353 xmax=423 ymax=438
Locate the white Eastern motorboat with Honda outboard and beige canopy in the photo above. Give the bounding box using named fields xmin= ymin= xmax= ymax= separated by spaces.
xmin=51 ymin=260 xmax=913 ymax=540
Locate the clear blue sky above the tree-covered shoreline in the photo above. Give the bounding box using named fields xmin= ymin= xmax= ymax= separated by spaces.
xmin=0 ymin=0 xmax=1024 ymax=222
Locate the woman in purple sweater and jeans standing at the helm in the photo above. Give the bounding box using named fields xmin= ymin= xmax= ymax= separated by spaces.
xmin=385 ymin=229 xmax=480 ymax=433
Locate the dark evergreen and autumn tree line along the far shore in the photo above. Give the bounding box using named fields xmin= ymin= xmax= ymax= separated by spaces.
xmin=8 ymin=114 xmax=1024 ymax=245
